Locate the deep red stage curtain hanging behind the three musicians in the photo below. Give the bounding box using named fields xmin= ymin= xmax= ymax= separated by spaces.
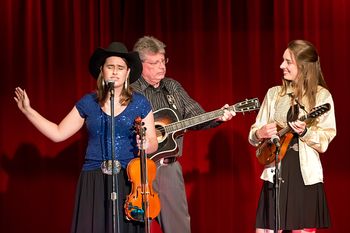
xmin=0 ymin=0 xmax=350 ymax=233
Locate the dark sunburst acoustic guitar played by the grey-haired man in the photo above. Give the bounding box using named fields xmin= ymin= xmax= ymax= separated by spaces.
xmin=148 ymin=98 xmax=260 ymax=162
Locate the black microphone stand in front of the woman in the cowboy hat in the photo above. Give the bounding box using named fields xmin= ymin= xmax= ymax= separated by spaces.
xmin=109 ymin=86 xmax=120 ymax=233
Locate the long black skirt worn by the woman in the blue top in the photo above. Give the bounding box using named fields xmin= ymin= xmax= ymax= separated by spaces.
xmin=71 ymin=169 xmax=145 ymax=233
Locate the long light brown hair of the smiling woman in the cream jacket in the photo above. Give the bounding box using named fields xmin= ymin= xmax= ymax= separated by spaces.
xmin=282 ymin=40 xmax=328 ymax=109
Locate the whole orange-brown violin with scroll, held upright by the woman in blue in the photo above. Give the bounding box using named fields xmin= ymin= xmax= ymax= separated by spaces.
xmin=124 ymin=117 xmax=160 ymax=232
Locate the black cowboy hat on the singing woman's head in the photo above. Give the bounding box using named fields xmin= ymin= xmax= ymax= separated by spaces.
xmin=89 ymin=42 xmax=142 ymax=83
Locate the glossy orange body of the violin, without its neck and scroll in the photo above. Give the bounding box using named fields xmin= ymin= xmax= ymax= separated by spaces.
xmin=124 ymin=158 xmax=160 ymax=222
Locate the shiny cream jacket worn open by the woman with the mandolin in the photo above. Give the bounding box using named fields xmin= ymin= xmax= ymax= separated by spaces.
xmin=249 ymin=86 xmax=336 ymax=185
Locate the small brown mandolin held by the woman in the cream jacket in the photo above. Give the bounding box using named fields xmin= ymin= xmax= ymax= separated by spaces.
xmin=256 ymin=103 xmax=331 ymax=165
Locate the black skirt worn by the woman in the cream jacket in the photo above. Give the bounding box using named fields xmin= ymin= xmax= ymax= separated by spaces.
xmin=256 ymin=138 xmax=330 ymax=230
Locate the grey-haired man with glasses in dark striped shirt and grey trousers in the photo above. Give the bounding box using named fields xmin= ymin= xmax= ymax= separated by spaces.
xmin=131 ymin=36 xmax=235 ymax=233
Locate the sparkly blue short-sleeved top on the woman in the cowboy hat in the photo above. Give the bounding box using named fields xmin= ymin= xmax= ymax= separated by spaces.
xmin=76 ymin=93 xmax=152 ymax=170
